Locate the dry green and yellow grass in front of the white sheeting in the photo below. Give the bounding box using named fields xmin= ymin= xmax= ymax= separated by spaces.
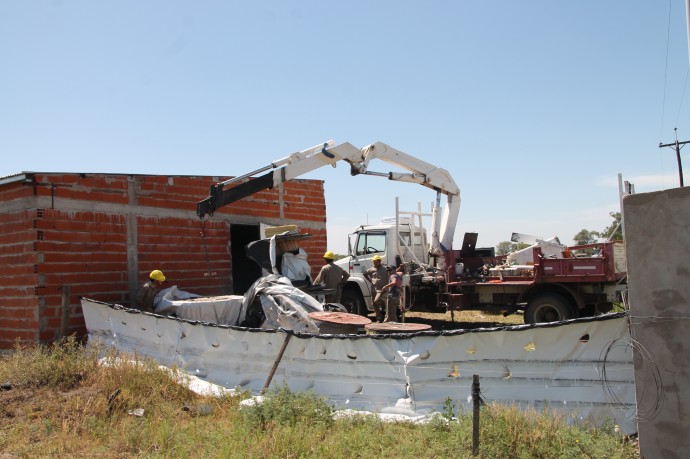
xmin=0 ymin=340 xmax=639 ymax=458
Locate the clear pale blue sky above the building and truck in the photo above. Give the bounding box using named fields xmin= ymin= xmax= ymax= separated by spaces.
xmin=0 ymin=0 xmax=690 ymax=253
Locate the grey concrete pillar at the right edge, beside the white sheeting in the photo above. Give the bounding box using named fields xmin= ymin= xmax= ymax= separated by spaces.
xmin=623 ymin=188 xmax=690 ymax=458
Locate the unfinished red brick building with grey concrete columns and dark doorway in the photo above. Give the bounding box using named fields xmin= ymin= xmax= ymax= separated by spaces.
xmin=0 ymin=172 xmax=326 ymax=350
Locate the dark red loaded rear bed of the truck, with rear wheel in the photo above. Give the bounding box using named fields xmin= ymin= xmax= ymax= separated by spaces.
xmin=445 ymin=233 xmax=627 ymax=323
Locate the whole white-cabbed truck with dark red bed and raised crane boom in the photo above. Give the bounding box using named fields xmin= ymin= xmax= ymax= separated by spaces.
xmin=197 ymin=141 xmax=627 ymax=323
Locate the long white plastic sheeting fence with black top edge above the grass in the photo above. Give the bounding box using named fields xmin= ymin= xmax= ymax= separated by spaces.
xmin=82 ymin=299 xmax=636 ymax=433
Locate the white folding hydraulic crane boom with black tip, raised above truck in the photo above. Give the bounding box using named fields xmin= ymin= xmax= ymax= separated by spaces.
xmin=197 ymin=140 xmax=460 ymax=256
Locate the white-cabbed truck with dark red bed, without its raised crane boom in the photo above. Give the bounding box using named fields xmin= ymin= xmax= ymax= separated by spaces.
xmin=336 ymin=211 xmax=627 ymax=323
